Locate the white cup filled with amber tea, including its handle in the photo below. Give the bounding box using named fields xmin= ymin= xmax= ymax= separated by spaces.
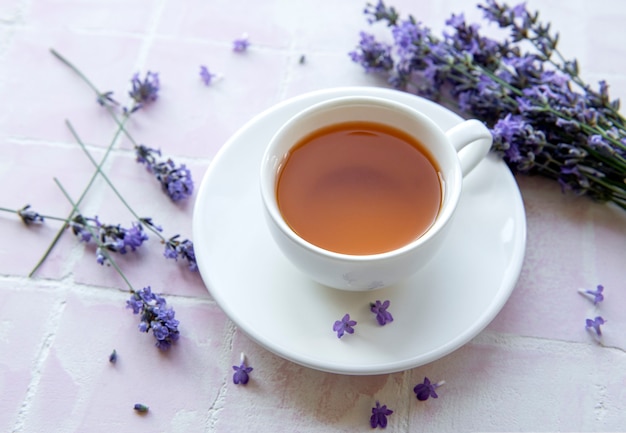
xmin=260 ymin=96 xmax=492 ymax=291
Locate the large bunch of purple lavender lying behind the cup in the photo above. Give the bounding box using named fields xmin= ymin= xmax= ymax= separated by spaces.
xmin=350 ymin=0 xmax=626 ymax=210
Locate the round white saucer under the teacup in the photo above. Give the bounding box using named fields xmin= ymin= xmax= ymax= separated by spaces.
xmin=193 ymin=87 xmax=526 ymax=375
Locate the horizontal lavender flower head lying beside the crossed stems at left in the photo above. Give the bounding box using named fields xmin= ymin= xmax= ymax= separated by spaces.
xmin=69 ymin=215 xmax=148 ymax=265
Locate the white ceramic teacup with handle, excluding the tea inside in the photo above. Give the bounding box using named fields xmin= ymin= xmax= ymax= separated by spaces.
xmin=260 ymin=96 xmax=492 ymax=291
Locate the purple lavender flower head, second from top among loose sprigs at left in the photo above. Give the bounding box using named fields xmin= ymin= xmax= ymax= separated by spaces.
xmin=135 ymin=144 xmax=194 ymax=201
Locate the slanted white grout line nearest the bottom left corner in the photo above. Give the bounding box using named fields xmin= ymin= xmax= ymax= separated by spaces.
xmin=12 ymin=299 xmax=66 ymax=433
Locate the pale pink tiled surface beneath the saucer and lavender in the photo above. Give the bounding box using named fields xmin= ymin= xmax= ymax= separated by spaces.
xmin=0 ymin=0 xmax=626 ymax=433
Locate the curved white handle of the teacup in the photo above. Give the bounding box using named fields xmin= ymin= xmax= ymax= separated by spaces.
xmin=446 ymin=119 xmax=493 ymax=177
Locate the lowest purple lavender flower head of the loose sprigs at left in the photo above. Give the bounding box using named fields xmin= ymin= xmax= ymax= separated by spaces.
xmin=126 ymin=286 xmax=179 ymax=351
